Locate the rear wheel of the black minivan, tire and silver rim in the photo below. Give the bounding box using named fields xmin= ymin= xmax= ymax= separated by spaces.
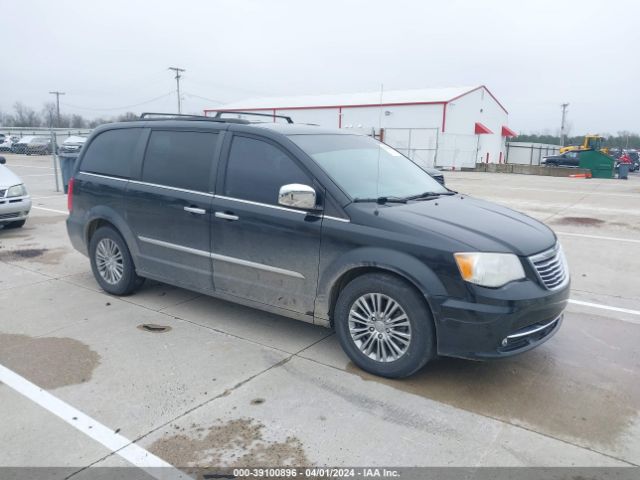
xmin=89 ymin=227 xmax=144 ymax=296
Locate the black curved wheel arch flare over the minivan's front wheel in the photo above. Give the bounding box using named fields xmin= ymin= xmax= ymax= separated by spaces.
xmin=315 ymin=247 xmax=446 ymax=323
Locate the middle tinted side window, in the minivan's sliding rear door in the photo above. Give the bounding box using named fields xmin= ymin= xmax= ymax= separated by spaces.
xmin=142 ymin=130 xmax=218 ymax=192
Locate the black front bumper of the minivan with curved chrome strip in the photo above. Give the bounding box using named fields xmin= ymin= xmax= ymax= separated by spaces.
xmin=431 ymin=280 xmax=570 ymax=359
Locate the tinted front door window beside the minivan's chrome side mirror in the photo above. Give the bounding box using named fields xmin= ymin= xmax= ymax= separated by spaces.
xmin=224 ymin=137 xmax=311 ymax=204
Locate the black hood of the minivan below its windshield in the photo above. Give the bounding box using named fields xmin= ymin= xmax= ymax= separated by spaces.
xmin=364 ymin=195 xmax=556 ymax=256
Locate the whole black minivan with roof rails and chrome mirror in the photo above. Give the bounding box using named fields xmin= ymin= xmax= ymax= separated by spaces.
xmin=67 ymin=116 xmax=569 ymax=377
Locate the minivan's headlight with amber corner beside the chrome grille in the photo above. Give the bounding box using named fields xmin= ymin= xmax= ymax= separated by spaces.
xmin=453 ymin=252 xmax=525 ymax=287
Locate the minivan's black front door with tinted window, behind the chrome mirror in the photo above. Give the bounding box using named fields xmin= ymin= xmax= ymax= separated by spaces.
xmin=211 ymin=134 xmax=321 ymax=315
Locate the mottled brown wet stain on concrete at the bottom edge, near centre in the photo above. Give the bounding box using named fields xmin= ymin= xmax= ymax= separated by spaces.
xmin=149 ymin=418 xmax=310 ymax=468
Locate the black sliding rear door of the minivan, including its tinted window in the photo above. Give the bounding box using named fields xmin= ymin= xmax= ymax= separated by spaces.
xmin=126 ymin=130 xmax=219 ymax=291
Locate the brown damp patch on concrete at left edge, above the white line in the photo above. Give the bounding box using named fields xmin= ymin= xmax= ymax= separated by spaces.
xmin=0 ymin=333 xmax=100 ymax=390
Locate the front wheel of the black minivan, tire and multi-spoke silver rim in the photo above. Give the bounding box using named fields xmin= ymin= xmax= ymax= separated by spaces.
xmin=334 ymin=273 xmax=436 ymax=378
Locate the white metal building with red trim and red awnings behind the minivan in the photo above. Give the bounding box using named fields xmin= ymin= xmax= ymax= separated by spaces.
xmin=205 ymin=85 xmax=515 ymax=168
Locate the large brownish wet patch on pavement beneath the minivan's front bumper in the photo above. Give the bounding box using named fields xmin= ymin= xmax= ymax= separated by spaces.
xmin=347 ymin=316 xmax=640 ymax=446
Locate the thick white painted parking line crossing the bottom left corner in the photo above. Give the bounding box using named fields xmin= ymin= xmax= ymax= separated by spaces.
xmin=0 ymin=365 xmax=190 ymax=479
